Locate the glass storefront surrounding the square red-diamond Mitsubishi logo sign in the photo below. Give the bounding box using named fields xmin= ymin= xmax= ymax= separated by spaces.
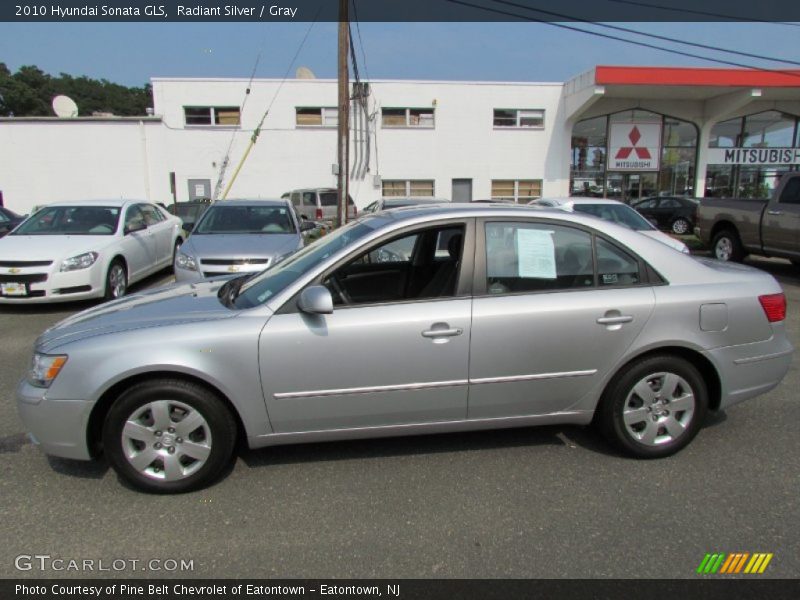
xmin=570 ymin=109 xmax=698 ymax=202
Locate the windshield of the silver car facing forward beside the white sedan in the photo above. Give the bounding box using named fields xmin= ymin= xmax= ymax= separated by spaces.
xmin=193 ymin=201 xmax=297 ymax=235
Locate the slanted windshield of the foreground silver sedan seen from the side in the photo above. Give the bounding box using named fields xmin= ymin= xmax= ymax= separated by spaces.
xmin=233 ymin=219 xmax=382 ymax=308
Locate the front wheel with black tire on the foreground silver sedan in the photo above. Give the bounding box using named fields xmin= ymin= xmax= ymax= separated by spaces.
xmin=103 ymin=379 xmax=236 ymax=494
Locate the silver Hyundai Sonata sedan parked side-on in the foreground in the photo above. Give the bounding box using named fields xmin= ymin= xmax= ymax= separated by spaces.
xmin=17 ymin=205 xmax=793 ymax=493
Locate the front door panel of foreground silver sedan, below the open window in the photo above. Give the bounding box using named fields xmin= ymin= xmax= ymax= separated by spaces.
xmin=259 ymin=298 xmax=471 ymax=433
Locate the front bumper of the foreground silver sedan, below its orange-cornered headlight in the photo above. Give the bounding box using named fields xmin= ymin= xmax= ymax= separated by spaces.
xmin=16 ymin=379 xmax=94 ymax=460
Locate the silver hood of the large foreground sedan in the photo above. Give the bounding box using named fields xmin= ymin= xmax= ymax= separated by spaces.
xmin=36 ymin=280 xmax=237 ymax=352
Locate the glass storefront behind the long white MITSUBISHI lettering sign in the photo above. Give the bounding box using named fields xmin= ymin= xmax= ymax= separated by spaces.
xmin=705 ymin=110 xmax=800 ymax=198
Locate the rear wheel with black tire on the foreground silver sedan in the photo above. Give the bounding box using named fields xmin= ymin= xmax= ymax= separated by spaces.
xmin=597 ymin=354 xmax=708 ymax=458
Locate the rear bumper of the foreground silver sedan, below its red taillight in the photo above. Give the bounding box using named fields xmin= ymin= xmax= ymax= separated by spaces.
xmin=706 ymin=335 xmax=794 ymax=409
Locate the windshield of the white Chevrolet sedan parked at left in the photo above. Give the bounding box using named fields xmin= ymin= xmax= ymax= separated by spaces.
xmin=11 ymin=206 xmax=120 ymax=235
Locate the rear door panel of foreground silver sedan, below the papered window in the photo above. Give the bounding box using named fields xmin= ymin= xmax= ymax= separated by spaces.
xmin=469 ymin=287 xmax=654 ymax=419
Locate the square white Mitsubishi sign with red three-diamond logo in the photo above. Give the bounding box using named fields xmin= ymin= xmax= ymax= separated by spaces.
xmin=607 ymin=122 xmax=661 ymax=171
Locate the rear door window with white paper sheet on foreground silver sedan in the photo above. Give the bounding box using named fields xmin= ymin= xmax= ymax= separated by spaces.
xmin=485 ymin=223 xmax=594 ymax=294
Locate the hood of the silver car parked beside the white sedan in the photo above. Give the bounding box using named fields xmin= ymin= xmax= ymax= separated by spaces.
xmin=181 ymin=233 xmax=300 ymax=258
